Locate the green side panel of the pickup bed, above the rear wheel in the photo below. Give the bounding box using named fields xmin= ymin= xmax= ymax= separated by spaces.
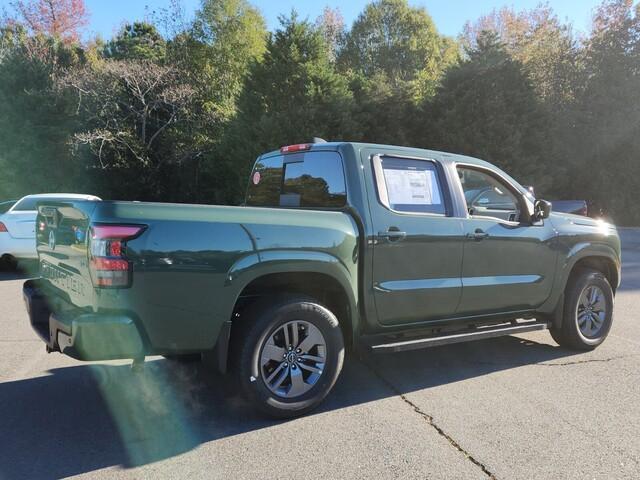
xmin=92 ymin=202 xmax=357 ymax=352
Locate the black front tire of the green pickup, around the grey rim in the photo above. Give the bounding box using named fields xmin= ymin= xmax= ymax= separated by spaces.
xmin=551 ymin=269 xmax=613 ymax=350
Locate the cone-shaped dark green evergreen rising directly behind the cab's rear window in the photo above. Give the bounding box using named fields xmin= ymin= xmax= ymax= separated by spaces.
xmin=220 ymin=13 xmax=355 ymax=200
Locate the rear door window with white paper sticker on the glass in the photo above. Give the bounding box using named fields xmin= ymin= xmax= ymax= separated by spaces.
xmin=374 ymin=157 xmax=446 ymax=215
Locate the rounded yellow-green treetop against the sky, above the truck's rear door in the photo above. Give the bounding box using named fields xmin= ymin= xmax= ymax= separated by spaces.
xmin=339 ymin=0 xmax=457 ymax=98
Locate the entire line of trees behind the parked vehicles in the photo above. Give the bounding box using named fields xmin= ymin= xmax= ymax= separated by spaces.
xmin=0 ymin=0 xmax=640 ymax=225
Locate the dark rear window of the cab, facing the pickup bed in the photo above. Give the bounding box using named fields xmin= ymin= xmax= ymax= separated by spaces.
xmin=246 ymin=152 xmax=347 ymax=208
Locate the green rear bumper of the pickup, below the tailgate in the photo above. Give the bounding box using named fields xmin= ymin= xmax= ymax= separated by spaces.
xmin=22 ymin=280 xmax=145 ymax=360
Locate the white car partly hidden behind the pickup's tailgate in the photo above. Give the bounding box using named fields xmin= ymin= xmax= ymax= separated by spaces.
xmin=0 ymin=193 xmax=100 ymax=268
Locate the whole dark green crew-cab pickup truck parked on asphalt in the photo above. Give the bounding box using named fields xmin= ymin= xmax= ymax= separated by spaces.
xmin=23 ymin=142 xmax=620 ymax=417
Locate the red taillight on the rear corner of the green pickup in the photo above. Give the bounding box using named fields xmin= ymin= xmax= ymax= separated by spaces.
xmin=89 ymin=225 xmax=146 ymax=288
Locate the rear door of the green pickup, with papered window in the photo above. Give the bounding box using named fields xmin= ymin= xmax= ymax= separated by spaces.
xmin=364 ymin=154 xmax=463 ymax=325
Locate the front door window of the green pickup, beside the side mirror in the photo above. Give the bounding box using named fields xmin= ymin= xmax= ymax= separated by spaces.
xmin=458 ymin=167 xmax=521 ymax=222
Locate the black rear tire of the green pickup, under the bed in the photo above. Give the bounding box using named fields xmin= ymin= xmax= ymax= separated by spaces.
xmin=233 ymin=297 xmax=344 ymax=418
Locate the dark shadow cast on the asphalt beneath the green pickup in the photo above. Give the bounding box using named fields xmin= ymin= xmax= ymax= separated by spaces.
xmin=0 ymin=337 xmax=574 ymax=478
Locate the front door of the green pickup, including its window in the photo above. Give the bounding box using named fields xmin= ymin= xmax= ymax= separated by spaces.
xmin=457 ymin=165 xmax=557 ymax=316
